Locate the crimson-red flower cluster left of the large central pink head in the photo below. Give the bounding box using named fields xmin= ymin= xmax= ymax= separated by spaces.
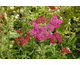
xmin=14 ymin=29 xmax=30 ymax=45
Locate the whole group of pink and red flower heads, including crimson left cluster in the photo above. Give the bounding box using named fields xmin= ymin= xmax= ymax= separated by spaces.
xmin=14 ymin=15 xmax=63 ymax=45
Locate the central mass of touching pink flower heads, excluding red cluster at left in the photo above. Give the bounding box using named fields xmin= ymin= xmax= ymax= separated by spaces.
xmin=30 ymin=15 xmax=63 ymax=44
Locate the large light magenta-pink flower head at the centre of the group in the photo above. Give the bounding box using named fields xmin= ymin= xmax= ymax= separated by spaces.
xmin=30 ymin=23 xmax=48 ymax=41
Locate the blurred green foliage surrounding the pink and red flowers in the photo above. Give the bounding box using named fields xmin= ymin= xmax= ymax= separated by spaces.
xmin=0 ymin=6 xmax=80 ymax=59
